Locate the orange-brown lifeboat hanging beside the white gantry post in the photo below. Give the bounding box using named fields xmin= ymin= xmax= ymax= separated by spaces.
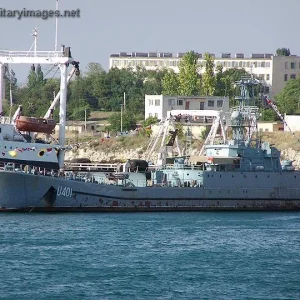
xmin=16 ymin=116 xmax=56 ymax=134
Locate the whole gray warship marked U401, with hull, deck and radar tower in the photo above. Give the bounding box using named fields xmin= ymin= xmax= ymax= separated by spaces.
xmin=0 ymin=71 xmax=300 ymax=212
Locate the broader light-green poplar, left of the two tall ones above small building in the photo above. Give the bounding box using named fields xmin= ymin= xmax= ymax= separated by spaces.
xmin=178 ymin=51 xmax=200 ymax=96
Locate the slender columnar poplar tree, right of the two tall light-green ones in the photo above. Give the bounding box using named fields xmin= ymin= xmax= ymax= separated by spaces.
xmin=202 ymin=53 xmax=216 ymax=96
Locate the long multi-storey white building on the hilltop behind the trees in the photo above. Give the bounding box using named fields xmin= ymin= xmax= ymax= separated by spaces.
xmin=109 ymin=52 xmax=300 ymax=97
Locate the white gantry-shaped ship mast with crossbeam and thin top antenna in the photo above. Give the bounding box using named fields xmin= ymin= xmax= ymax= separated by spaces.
xmin=0 ymin=29 xmax=73 ymax=167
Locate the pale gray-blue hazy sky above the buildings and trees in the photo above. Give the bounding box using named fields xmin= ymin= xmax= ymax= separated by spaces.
xmin=0 ymin=0 xmax=300 ymax=82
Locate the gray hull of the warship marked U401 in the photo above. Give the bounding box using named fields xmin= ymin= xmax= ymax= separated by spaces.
xmin=0 ymin=171 xmax=300 ymax=212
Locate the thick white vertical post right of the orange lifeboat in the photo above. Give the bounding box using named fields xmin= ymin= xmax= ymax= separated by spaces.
xmin=58 ymin=64 xmax=68 ymax=168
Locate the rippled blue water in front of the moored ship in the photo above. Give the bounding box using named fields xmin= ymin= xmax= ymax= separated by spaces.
xmin=0 ymin=212 xmax=300 ymax=299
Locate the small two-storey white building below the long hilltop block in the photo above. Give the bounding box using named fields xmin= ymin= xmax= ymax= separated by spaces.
xmin=145 ymin=95 xmax=229 ymax=120
